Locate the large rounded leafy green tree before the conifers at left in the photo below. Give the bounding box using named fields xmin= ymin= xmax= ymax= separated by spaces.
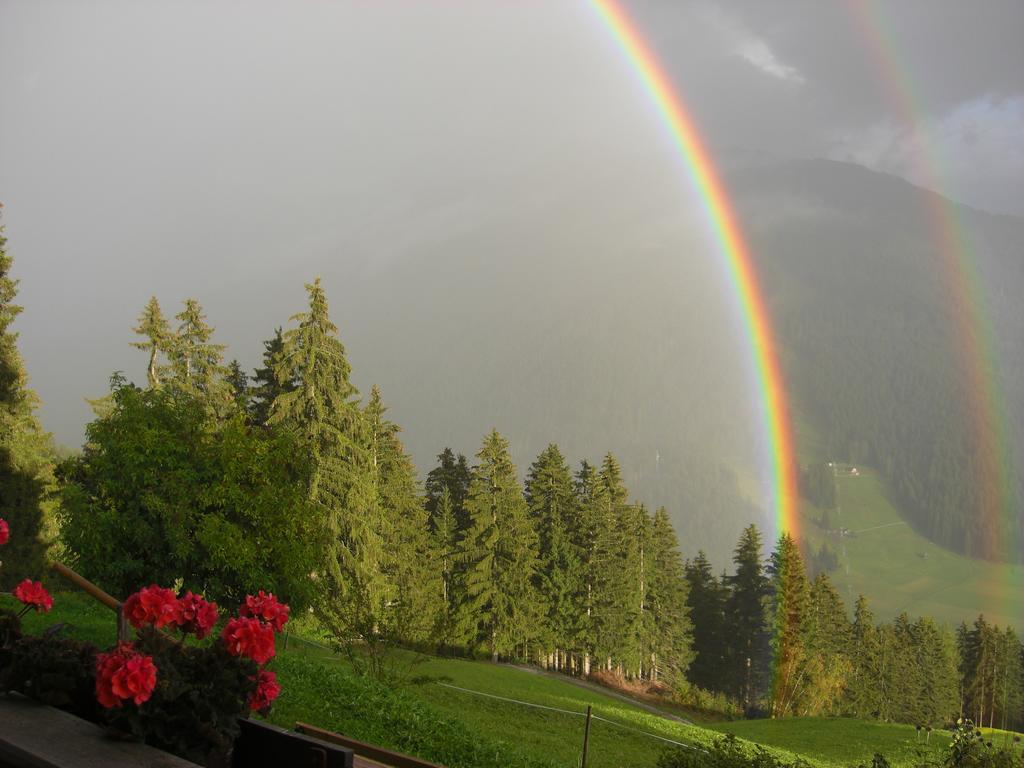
xmin=61 ymin=385 xmax=321 ymax=610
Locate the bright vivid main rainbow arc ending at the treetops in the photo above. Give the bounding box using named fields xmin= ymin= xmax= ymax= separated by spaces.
xmin=591 ymin=0 xmax=799 ymax=538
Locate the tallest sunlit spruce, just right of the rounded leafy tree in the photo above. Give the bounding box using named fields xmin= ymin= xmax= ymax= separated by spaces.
xmin=269 ymin=279 xmax=389 ymax=639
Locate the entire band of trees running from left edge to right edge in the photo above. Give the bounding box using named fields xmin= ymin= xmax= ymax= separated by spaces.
xmin=0 ymin=227 xmax=1024 ymax=725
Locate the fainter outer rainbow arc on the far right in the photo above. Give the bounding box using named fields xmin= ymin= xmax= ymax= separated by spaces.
xmin=847 ymin=2 xmax=1016 ymax=559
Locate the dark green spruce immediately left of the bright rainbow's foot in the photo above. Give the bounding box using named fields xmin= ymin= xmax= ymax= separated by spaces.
xmin=725 ymin=525 xmax=770 ymax=709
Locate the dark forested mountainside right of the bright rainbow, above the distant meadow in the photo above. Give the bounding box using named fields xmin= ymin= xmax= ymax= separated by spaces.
xmin=731 ymin=161 xmax=1024 ymax=559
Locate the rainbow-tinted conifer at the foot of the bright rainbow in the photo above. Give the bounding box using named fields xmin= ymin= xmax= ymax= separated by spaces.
xmin=768 ymin=534 xmax=810 ymax=717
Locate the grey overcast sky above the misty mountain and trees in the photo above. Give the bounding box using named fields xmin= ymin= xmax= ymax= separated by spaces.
xmin=0 ymin=0 xmax=1024 ymax=444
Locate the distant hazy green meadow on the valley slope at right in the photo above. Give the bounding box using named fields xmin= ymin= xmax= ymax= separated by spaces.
xmin=801 ymin=467 xmax=1024 ymax=629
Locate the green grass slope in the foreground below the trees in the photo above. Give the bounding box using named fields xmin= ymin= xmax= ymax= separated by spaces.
xmin=0 ymin=593 xmax=966 ymax=768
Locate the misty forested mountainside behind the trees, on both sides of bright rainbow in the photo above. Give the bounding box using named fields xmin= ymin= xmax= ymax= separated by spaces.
xmin=329 ymin=155 xmax=1024 ymax=564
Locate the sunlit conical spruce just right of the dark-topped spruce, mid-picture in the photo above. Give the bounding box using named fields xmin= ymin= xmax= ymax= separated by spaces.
xmin=459 ymin=430 xmax=540 ymax=660
